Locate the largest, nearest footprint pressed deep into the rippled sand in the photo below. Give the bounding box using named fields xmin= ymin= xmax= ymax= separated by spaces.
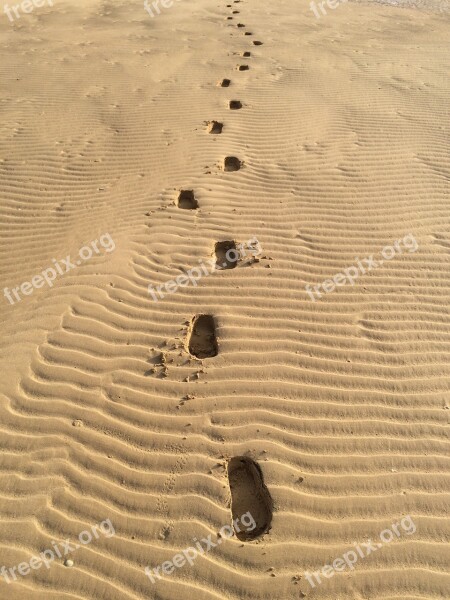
xmin=228 ymin=456 xmax=273 ymax=541
